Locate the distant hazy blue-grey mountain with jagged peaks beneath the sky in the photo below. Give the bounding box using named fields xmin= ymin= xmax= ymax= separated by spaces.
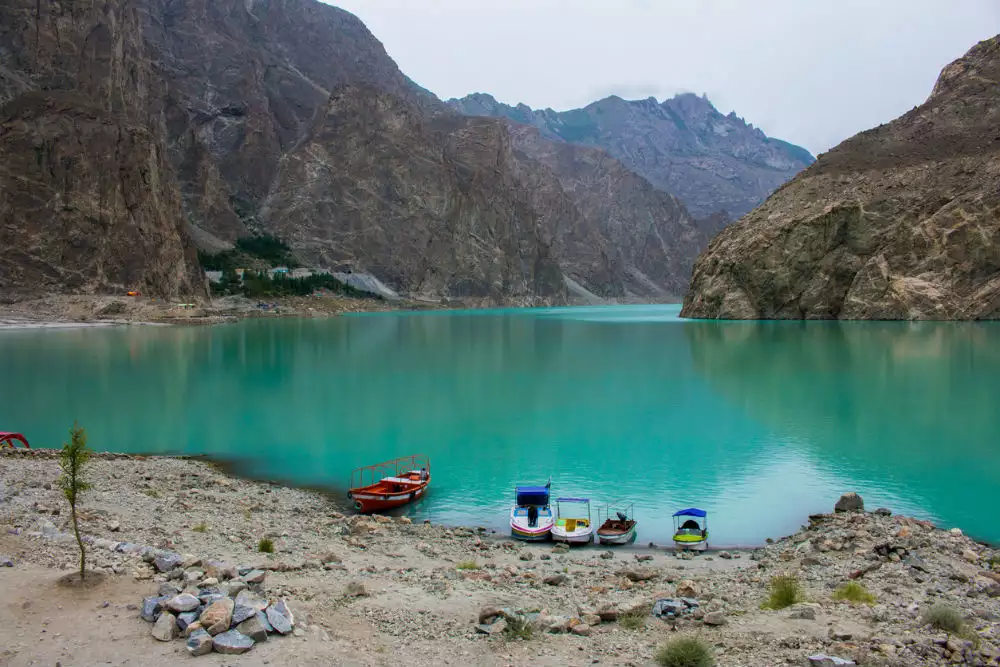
xmin=448 ymin=93 xmax=813 ymax=217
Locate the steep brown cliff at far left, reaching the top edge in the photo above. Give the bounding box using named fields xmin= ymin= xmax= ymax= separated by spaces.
xmin=0 ymin=0 xmax=205 ymax=298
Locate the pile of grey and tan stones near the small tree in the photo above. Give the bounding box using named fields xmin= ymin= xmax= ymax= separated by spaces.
xmin=140 ymin=553 xmax=301 ymax=655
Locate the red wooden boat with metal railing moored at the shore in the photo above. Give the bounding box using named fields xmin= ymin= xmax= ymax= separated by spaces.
xmin=347 ymin=455 xmax=431 ymax=514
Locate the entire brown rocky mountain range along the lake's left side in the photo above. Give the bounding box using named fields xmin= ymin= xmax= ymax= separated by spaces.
xmin=0 ymin=0 xmax=732 ymax=303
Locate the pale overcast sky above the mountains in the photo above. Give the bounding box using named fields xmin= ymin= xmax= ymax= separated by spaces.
xmin=330 ymin=0 xmax=1000 ymax=154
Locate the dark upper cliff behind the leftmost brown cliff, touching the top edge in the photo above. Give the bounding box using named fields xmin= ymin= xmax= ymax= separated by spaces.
xmin=140 ymin=0 xmax=442 ymax=245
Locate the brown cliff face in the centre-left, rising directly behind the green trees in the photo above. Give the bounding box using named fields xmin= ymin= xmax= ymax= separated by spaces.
xmin=261 ymin=86 xmax=566 ymax=303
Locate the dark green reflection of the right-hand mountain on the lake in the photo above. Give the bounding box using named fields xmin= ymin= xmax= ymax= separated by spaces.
xmin=684 ymin=322 xmax=1000 ymax=539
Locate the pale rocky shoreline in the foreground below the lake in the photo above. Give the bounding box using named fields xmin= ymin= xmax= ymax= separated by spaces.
xmin=0 ymin=450 xmax=1000 ymax=667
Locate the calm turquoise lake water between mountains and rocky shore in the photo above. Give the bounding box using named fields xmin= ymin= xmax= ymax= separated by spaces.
xmin=0 ymin=306 xmax=1000 ymax=545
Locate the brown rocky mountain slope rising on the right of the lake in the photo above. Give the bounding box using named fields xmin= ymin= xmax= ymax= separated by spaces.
xmin=682 ymin=36 xmax=1000 ymax=319
